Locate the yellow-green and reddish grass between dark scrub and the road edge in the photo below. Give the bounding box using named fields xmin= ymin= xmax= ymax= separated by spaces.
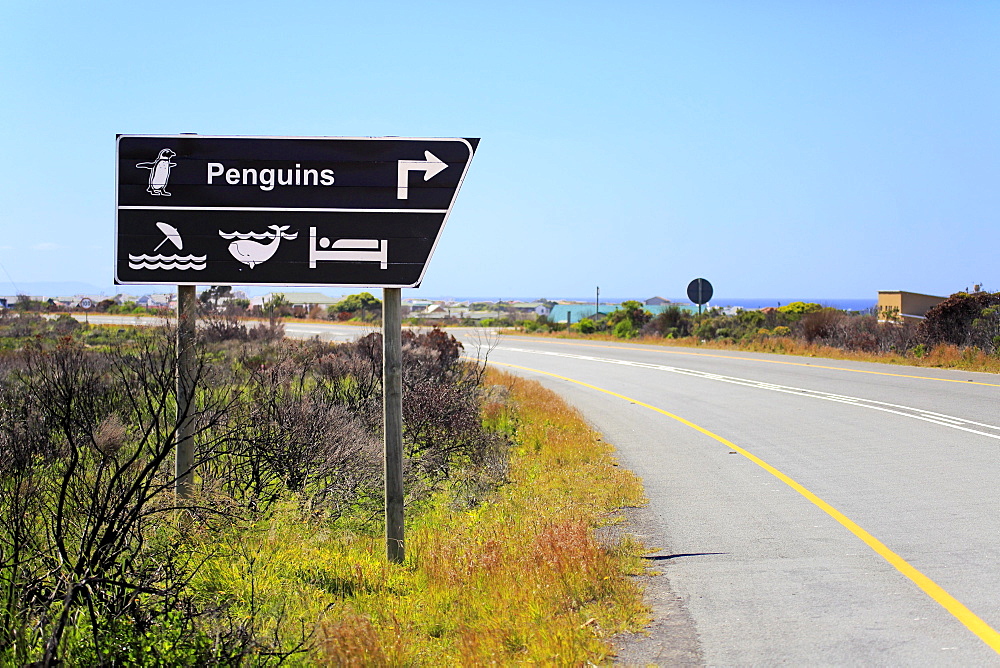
xmin=183 ymin=372 xmax=649 ymax=666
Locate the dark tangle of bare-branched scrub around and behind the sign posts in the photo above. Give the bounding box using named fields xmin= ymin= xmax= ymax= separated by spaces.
xmin=0 ymin=316 xmax=509 ymax=665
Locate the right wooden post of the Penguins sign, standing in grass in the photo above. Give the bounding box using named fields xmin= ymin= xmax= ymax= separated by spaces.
xmin=382 ymin=288 xmax=404 ymax=564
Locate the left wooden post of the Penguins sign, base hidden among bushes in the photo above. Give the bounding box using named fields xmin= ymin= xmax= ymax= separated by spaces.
xmin=174 ymin=285 xmax=198 ymax=504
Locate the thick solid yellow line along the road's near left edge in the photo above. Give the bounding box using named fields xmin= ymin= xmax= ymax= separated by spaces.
xmin=489 ymin=360 xmax=1000 ymax=654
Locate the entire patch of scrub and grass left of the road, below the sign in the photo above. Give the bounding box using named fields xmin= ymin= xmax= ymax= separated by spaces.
xmin=0 ymin=314 xmax=648 ymax=666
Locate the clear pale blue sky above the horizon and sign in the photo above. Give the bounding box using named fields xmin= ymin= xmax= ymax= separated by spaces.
xmin=0 ymin=0 xmax=1000 ymax=298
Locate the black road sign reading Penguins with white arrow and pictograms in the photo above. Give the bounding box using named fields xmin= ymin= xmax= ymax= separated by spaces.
xmin=115 ymin=135 xmax=479 ymax=287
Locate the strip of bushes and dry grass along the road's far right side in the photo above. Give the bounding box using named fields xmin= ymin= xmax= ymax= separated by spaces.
xmin=522 ymin=292 xmax=1000 ymax=373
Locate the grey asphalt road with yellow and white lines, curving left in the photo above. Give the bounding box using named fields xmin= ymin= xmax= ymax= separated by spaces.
xmin=70 ymin=323 xmax=1000 ymax=666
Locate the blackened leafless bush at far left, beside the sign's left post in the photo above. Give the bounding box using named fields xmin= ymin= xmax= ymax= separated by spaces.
xmin=0 ymin=330 xmax=208 ymax=665
